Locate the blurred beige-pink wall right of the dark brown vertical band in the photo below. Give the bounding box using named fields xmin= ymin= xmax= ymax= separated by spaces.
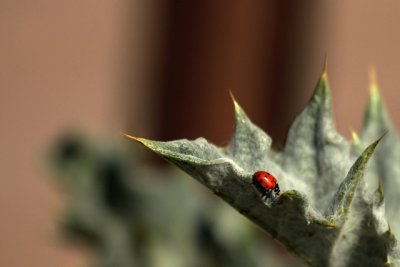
xmin=324 ymin=0 xmax=400 ymax=136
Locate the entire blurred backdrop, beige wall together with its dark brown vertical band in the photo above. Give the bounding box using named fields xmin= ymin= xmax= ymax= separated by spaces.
xmin=0 ymin=0 xmax=400 ymax=267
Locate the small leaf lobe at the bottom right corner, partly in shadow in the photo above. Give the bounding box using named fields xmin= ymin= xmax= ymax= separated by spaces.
xmin=330 ymin=186 xmax=398 ymax=266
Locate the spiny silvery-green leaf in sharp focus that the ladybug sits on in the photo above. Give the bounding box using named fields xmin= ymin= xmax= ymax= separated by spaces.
xmin=130 ymin=73 xmax=397 ymax=266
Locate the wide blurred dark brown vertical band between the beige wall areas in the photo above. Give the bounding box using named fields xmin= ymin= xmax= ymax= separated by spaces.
xmin=129 ymin=0 xmax=325 ymax=147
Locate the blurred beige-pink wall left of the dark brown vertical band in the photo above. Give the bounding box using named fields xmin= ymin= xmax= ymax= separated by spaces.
xmin=0 ymin=0 xmax=153 ymax=267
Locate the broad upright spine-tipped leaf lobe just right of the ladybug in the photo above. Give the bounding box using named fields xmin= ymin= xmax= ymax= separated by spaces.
xmin=281 ymin=73 xmax=351 ymax=210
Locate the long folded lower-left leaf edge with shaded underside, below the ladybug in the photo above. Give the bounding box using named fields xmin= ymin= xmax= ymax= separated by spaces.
xmin=130 ymin=134 xmax=336 ymax=265
